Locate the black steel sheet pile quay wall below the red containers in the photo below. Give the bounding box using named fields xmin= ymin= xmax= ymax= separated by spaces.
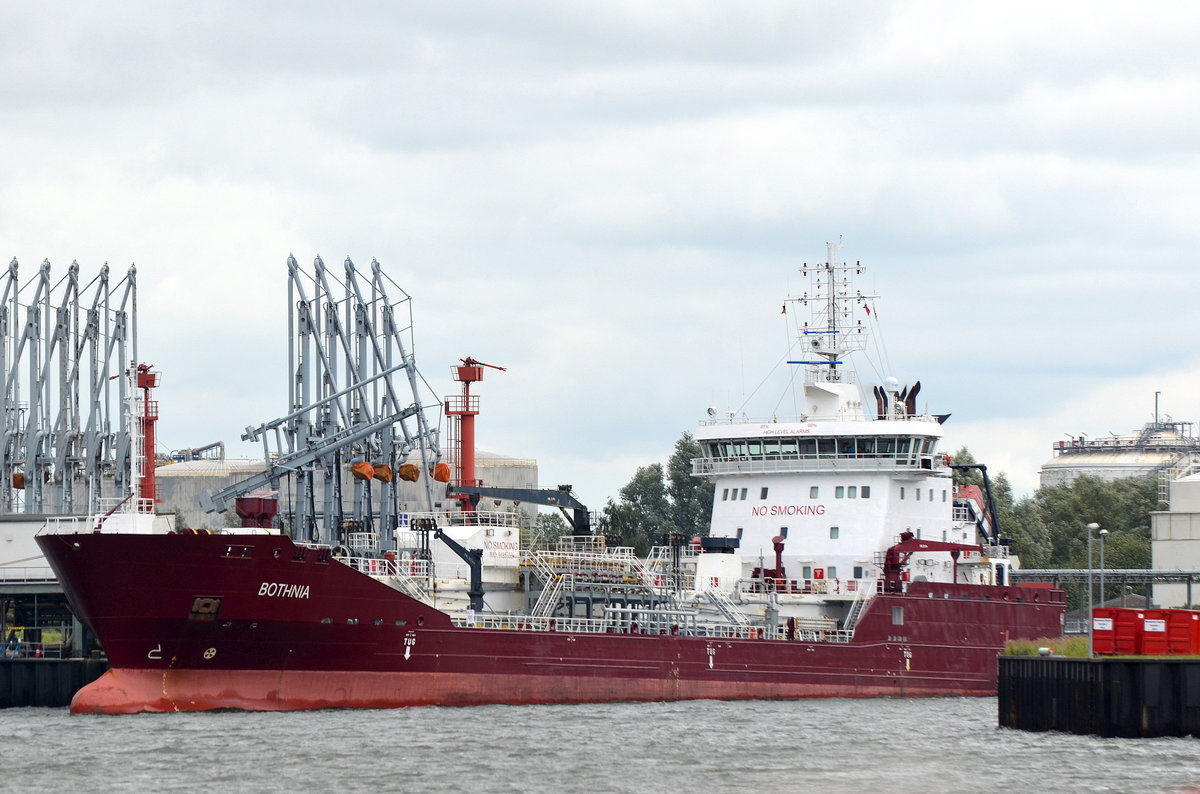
xmin=998 ymin=656 xmax=1200 ymax=736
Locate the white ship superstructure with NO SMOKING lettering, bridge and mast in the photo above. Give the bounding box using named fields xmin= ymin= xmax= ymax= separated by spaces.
xmin=692 ymin=243 xmax=1007 ymax=597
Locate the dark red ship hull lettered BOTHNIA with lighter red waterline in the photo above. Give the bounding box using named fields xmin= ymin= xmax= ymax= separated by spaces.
xmin=38 ymin=534 xmax=1064 ymax=714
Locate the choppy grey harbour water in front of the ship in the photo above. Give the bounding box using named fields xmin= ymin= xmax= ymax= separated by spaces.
xmin=0 ymin=698 xmax=1200 ymax=794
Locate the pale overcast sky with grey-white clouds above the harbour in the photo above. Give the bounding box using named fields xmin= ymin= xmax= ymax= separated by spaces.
xmin=0 ymin=0 xmax=1200 ymax=507
